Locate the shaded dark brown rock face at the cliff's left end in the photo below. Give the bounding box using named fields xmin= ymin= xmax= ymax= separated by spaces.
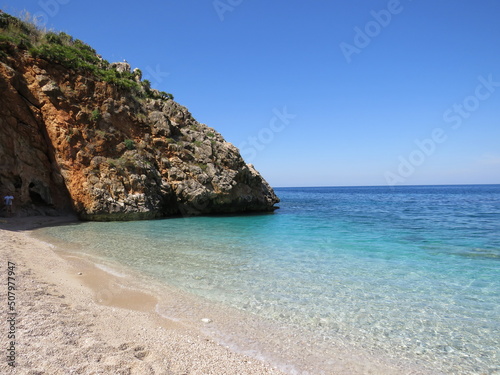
xmin=0 ymin=63 xmax=72 ymax=214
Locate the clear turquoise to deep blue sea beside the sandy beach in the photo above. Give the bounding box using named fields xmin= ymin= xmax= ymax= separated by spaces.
xmin=38 ymin=185 xmax=500 ymax=375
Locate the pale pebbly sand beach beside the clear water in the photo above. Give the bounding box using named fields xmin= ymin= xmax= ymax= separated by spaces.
xmin=0 ymin=218 xmax=281 ymax=375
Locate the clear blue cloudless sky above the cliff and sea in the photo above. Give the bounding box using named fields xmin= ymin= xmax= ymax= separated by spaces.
xmin=0 ymin=0 xmax=500 ymax=186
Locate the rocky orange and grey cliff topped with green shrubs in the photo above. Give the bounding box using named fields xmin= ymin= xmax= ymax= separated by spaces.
xmin=0 ymin=14 xmax=279 ymax=220
